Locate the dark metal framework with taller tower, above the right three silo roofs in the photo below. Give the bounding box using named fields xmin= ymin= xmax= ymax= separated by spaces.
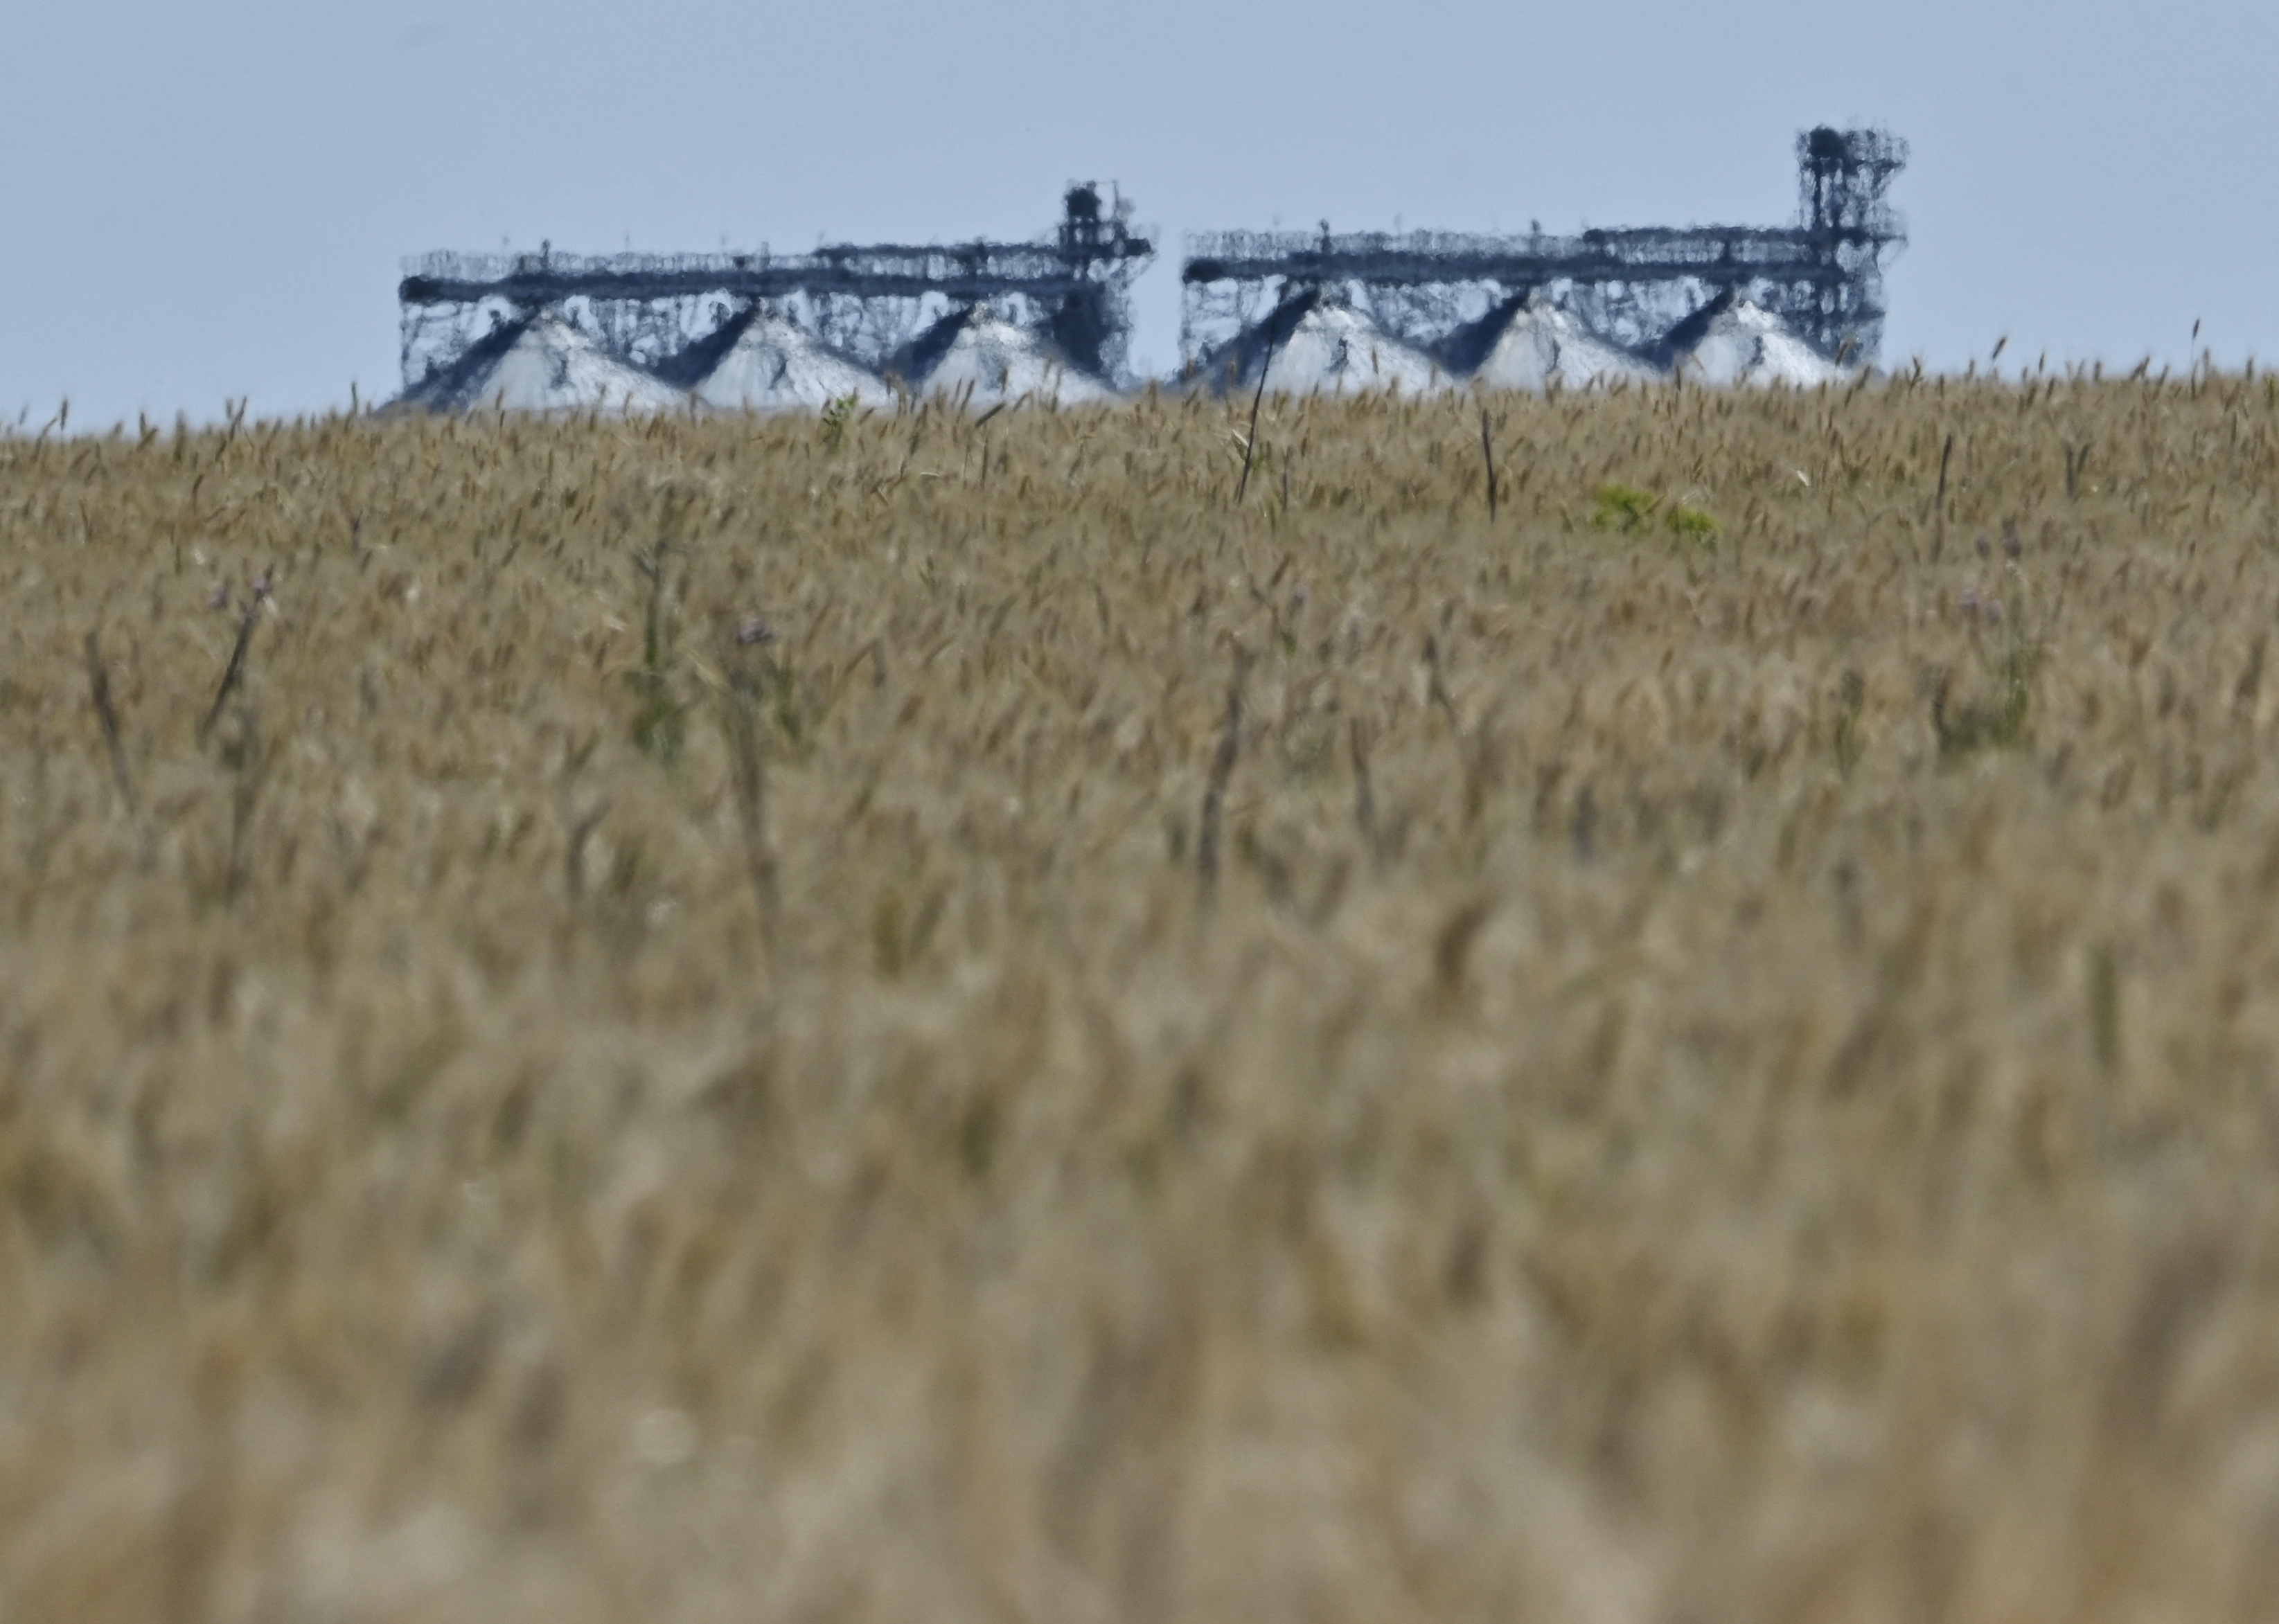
xmin=1180 ymin=127 xmax=1908 ymax=367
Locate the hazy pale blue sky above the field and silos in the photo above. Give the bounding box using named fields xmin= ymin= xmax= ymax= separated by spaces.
xmin=0 ymin=0 xmax=2279 ymax=426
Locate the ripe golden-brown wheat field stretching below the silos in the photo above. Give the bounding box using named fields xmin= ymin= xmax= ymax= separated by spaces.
xmin=0 ymin=371 xmax=2279 ymax=1624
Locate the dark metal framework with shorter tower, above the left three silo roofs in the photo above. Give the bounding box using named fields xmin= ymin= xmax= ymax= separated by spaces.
xmin=396 ymin=182 xmax=1155 ymax=389
